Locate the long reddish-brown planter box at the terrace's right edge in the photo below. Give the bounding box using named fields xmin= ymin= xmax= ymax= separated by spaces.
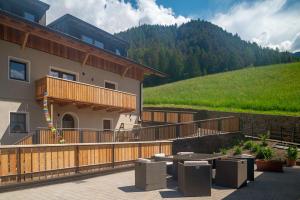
xmin=255 ymin=160 xmax=283 ymax=172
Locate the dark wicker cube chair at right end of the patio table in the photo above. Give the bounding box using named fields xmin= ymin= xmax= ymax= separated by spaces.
xmin=215 ymin=159 xmax=247 ymax=188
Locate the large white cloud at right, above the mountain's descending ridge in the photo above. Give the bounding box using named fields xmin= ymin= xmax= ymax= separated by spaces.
xmin=212 ymin=0 xmax=300 ymax=51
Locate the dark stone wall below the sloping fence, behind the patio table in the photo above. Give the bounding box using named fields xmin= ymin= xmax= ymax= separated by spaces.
xmin=172 ymin=133 xmax=244 ymax=155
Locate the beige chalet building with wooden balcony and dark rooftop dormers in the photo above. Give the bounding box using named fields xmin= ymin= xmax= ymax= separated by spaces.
xmin=0 ymin=0 xmax=164 ymax=144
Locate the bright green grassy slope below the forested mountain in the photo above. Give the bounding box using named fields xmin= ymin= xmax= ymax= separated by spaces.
xmin=144 ymin=63 xmax=300 ymax=116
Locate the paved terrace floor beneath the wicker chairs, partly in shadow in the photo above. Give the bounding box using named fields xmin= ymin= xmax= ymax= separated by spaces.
xmin=0 ymin=167 xmax=300 ymax=200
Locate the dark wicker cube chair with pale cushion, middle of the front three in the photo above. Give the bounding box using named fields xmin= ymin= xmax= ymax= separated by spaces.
xmin=178 ymin=161 xmax=211 ymax=197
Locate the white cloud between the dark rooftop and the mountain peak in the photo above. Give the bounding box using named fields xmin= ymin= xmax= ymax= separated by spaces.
xmin=43 ymin=0 xmax=190 ymax=33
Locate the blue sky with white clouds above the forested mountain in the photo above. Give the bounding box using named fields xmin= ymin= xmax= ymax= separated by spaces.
xmin=42 ymin=0 xmax=300 ymax=52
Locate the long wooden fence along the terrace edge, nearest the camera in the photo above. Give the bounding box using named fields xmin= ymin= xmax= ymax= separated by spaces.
xmin=0 ymin=141 xmax=172 ymax=188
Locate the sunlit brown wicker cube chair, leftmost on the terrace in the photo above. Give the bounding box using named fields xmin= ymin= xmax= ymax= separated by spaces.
xmin=135 ymin=159 xmax=167 ymax=191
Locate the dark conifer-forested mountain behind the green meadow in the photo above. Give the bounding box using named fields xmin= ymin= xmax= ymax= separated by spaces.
xmin=116 ymin=20 xmax=297 ymax=86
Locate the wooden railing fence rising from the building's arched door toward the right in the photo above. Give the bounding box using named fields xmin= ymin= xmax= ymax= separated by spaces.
xmin=16 ymin=117 xmax=240 ymax=144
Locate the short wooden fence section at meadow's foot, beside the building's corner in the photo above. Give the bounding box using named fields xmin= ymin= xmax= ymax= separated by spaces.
xmin=143 ymin=110 xmax=196 ymax=123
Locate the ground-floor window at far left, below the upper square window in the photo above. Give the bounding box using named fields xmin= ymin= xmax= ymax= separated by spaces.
xmin=9 ymin=113 xmax=27 ymax=133
